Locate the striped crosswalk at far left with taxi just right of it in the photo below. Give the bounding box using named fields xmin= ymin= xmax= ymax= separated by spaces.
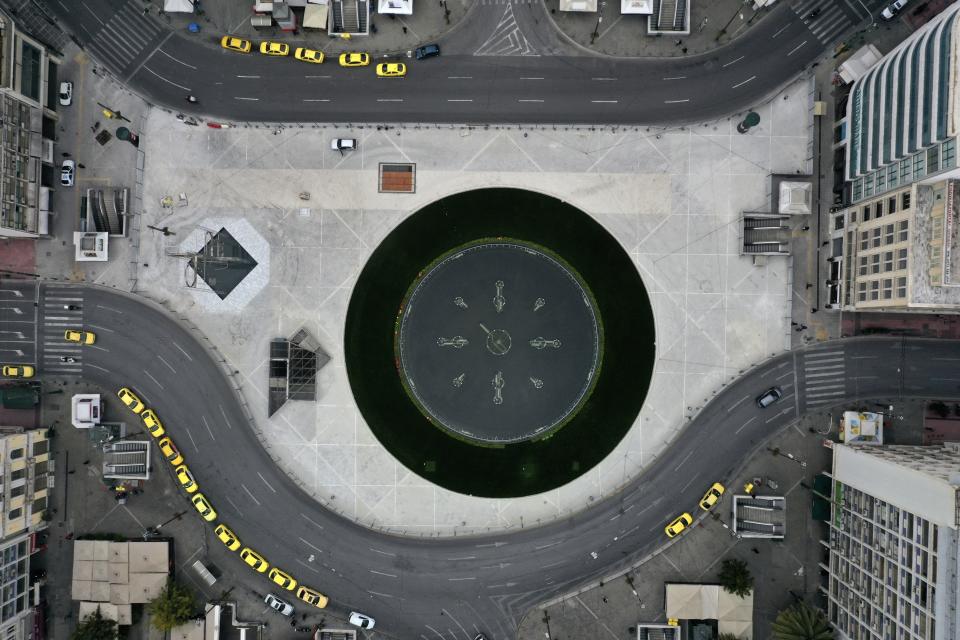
xmin=37 ymin=285 xmax=83 ymax=376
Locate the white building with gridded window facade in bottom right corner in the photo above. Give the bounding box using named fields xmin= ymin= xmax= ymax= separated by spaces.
xmin=820 ymin=443 xmax=960 ymax=640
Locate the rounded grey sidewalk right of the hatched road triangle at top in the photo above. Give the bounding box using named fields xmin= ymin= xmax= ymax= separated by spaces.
xmin=545 ymin=0 xmax=777 ymax=57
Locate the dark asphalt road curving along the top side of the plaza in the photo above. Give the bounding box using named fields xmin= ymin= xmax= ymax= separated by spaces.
xmin=37 ymin=0 xmax=885 ymax=125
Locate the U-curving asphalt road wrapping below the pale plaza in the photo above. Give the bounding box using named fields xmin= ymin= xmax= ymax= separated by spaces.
xmin=47 ymin=286 xmax=960 ymax=640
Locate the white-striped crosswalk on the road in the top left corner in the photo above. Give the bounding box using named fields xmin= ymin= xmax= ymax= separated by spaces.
xmin=88 ymin=2 xmax=164 ymax=76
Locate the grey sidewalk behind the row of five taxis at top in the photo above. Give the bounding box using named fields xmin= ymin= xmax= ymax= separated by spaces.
xmin=147 ymin=0 xmax=475 ymax=56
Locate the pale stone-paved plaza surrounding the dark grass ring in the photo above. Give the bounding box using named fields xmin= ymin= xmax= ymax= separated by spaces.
xmin=118 ymin=76 xmax=812 ymax=535
